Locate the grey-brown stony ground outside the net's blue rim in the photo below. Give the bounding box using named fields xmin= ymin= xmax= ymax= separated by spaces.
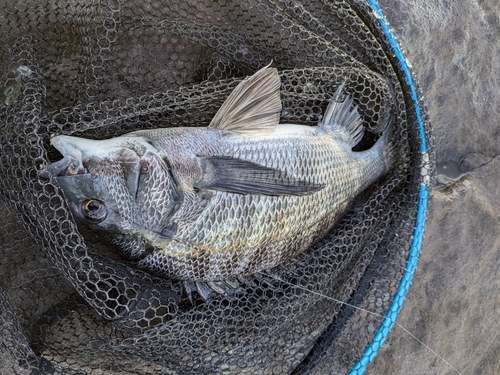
xmin=366 ymin=0 xmax=500 ymax=375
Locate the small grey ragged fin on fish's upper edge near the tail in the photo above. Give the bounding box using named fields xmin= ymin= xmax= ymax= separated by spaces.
xmin=319 ymin=84 xmax=365 ymax=147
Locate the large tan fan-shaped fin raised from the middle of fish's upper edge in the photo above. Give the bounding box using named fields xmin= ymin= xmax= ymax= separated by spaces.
xmin=209 ymin=66 xmax=281 ymax=134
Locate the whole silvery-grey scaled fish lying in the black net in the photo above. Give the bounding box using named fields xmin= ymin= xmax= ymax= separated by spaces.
xmin=47 ymin=66 xmax=394 ymax=290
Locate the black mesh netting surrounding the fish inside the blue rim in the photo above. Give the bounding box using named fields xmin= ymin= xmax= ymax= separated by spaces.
xmin=0 ymin=0 xmax=432 ymax=375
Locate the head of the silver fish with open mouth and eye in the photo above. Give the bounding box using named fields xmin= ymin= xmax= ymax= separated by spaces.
xmin=47 ymin=136 xmax=178 ymax=253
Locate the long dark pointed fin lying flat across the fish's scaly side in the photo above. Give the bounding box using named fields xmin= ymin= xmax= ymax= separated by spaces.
xmin=194 ymin=157 xmax=323 ymax=196
